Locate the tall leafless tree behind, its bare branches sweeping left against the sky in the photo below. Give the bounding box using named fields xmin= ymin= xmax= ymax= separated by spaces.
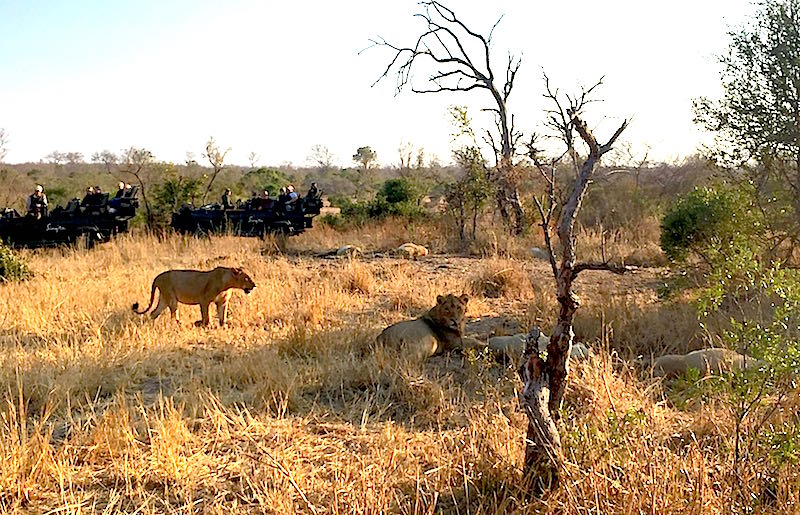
xmin=370 ymin=0 xmax=525 ymax=234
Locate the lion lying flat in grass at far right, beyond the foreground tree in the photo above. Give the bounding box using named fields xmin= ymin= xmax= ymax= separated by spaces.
xmin=653 ymin=349 xmax=766 ymax=377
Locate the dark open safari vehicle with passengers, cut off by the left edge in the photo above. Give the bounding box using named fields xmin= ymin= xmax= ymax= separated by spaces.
xmin=0 ymin=186 xmax=139 ymax=248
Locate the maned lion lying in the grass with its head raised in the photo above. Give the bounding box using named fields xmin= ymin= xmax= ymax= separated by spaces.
xmin=377 ymin=294 xmax=472 ymax=361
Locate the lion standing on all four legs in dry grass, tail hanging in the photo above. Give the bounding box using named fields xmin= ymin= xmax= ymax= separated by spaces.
xmin=132 ymin=266 xmax=256 ymax=326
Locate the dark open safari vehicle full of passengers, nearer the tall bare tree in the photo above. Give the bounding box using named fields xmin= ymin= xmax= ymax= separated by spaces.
xmin=171 ymin=190 xmax=322 ymax=237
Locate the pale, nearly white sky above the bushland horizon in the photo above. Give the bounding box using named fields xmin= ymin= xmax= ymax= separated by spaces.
xmin=0 ymin=0 xmax=754 ymax=166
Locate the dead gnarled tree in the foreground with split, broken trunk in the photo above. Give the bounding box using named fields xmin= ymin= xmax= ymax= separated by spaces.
xmin=519 ymin=75 xmax=628 ymax=491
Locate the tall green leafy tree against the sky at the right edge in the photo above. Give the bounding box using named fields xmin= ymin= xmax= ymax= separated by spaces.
xmin=694 ymin=0 xmax=800 ymax=253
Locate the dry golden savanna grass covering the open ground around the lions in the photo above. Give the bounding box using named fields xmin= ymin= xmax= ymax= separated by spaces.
xmin=0 ymin=228 xmax=800 ymax=514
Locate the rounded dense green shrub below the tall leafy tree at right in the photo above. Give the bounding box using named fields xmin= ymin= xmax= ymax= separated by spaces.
xmin=661 ymin=186 xmax=763 ymax=265
